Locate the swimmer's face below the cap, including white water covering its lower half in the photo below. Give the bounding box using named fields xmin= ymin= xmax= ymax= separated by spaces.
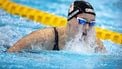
xmin=67 ymin=13 xmax=96 ymax=52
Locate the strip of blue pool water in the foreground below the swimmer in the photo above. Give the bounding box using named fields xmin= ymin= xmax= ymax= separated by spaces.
xmin=0 ymin=51 xmax=122 ymax=69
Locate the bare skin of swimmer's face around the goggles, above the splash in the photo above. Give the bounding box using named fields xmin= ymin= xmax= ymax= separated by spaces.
xmin=67 ymin=13 xmax=95 ymax=37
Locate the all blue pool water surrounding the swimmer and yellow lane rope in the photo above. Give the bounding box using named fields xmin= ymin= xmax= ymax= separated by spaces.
xmin=0 ymin=0 xmax=122 ymax=69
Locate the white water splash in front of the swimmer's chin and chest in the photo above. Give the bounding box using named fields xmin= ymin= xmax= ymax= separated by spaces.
xmin=65 ymin=26 xmax=97 ymax=53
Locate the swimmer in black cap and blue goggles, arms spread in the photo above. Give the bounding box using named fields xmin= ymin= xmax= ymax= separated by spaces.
xmin=7 ymin=0 xmax=106 ymax=52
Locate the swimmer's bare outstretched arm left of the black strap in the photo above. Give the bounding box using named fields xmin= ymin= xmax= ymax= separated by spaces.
xmin=7 ymin=28 xmax=54 ymax=52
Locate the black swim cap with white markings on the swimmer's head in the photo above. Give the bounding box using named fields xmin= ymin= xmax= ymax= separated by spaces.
xmin=68 ymin=0 xmax=96 ymax=21
